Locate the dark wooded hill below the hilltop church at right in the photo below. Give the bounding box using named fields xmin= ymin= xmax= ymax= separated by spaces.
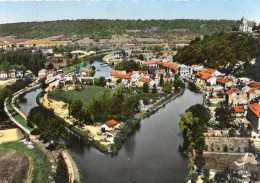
xmin=174 ymin=33 xmax=260 ymax=81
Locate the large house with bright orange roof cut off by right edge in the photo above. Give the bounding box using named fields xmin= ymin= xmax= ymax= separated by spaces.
xmin=246 ymin=103 xmax=260 ymax=132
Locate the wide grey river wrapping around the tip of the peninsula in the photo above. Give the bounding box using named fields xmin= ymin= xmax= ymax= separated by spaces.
xmin=17 ymin=84 xmax=202 ymax=183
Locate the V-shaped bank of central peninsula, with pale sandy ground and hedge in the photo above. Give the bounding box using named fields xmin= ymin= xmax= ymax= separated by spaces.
xmin=39 ymin=83 xmax=184 ymax=153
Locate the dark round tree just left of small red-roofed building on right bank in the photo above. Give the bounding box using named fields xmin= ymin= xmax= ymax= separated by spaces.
xmin=215 ymin=106 xmax=234 ymax=129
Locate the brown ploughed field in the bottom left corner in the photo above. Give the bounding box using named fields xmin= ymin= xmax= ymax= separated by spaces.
xmin=0 ymin=150 xmax=30 ymax=183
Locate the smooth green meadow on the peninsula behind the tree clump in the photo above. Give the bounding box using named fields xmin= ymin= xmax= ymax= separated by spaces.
xmin=48 ymin=85 xmax=106 ymax=105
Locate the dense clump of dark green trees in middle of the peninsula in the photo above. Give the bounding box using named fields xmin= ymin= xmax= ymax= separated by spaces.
xmin=68 ymin=84 xmax=139 ymax=124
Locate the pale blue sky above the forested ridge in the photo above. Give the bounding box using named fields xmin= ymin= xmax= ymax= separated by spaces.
xmin=0 ymin=0 xmax=260 ymax=24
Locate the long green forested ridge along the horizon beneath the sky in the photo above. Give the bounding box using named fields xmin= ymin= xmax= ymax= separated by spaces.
xmin=0 ymin=19 xmax=239 ymax=38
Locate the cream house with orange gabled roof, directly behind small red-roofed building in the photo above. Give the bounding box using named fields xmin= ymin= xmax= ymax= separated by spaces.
xmin=225 ymin=88 xmax=247 ymax=106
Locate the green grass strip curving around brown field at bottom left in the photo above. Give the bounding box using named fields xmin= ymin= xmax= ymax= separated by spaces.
xmin=0 ymin=142 xmax=52 ymax=183
